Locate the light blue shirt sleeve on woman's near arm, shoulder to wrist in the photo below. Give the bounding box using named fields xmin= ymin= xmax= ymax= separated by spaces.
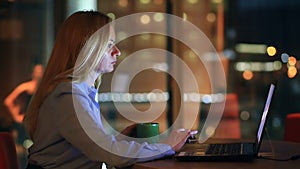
xmin=56 ymin=94 xmax=174 ymax=167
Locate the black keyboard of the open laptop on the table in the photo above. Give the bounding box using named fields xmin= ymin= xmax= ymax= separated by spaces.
xmin=206 ymin=143 xmax=242 ymax=155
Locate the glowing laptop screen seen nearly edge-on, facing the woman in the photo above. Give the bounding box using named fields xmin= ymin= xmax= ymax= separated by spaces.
xmin=257 ymin=84 xmax=275 ymax=143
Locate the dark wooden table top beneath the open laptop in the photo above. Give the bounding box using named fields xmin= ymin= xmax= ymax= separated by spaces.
xmin=133 ymin=141 xmax=300 ymax=169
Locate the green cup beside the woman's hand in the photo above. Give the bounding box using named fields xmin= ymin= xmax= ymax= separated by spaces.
xmin=136 ymin=123 xmax=159 ymax=143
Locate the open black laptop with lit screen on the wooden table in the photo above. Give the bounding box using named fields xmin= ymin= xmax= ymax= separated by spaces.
xmin=174 ymin=83 xmax=276 ymax=162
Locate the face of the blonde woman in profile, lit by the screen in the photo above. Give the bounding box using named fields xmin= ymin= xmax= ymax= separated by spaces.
xmin=97 ymin=27 xmax=121 ymax=73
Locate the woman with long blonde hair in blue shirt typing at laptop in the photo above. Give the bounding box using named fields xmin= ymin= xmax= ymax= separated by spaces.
xmin=25 ymin=11 xmax=189 ymax=169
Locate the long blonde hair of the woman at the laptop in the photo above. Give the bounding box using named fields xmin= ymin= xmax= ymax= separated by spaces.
xmin=24 ymin=11 xmax=111 ymax=137
